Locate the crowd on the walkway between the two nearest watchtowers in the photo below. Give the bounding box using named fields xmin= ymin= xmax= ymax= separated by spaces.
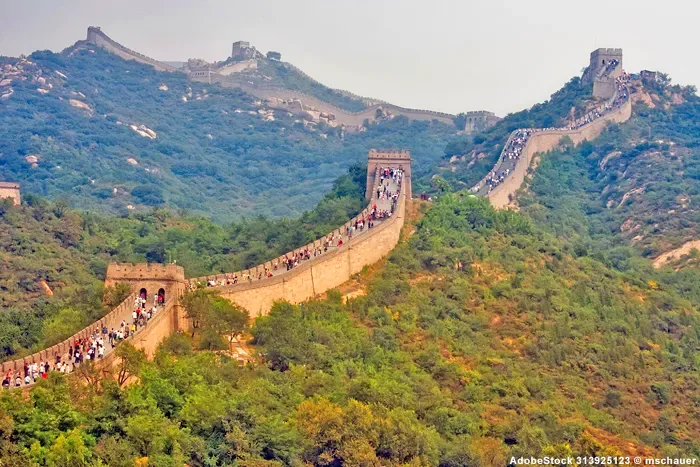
xmin=191 ymin=167 xmax=404 ymax=290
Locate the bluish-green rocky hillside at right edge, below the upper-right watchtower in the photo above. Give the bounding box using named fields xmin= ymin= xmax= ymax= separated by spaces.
xmin=520 ymin=78 xmax=700 ymax=264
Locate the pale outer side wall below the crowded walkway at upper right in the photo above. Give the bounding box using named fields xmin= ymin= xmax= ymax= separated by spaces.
xmin=488 ymin=99 xmax=632 ymax=209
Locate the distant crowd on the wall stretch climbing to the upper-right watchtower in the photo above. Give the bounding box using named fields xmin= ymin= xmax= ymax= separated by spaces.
xmin=472 ymin=65 xmax=629 ymax=195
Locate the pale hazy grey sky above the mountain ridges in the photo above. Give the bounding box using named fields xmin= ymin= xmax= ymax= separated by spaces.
xmin=0 ymin=0 xmax=700 ymax=115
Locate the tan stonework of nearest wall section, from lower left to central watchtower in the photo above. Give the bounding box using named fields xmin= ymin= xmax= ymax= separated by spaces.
xmin=0 ymin=156 xmax=411 ymax=380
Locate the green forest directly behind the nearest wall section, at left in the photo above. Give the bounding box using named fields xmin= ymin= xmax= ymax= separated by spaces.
xmin=0 ymin=166 xmax=367 ymax=358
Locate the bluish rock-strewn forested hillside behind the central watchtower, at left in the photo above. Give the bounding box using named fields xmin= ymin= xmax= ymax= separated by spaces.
xmin=0 ymin=45 xmax=456 ymax=222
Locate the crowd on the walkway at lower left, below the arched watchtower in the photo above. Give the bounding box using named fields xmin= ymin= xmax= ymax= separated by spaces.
xmin=2 ymin=295 xmax=164 ymax=389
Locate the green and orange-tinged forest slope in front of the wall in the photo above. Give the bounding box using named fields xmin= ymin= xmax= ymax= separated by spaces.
xmin=0 ymin=194 xmax=700 ymax=466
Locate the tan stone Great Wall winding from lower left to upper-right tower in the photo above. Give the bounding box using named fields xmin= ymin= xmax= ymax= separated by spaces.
xmin=2 ymin=42 xmax=632 ymax=380
